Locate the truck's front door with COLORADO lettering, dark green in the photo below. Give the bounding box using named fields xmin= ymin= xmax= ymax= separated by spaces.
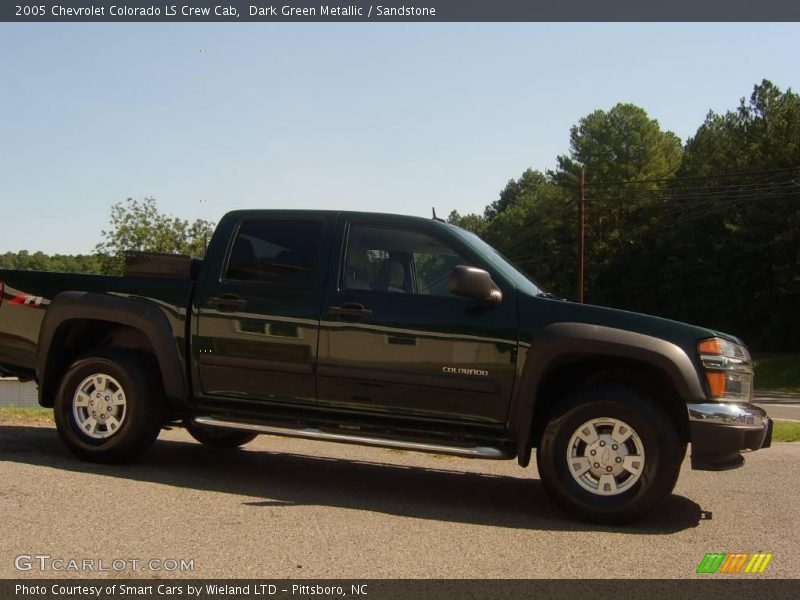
xmin=318 ymin=218 xmax=517 ymax=424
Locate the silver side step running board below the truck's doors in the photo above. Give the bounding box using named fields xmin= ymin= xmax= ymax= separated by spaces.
xmin=194 ymin=417 xmax=514 ymax=460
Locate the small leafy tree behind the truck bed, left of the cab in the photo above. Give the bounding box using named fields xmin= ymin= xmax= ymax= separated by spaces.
xmin=95 ymin=198 xmax=214 ymax=273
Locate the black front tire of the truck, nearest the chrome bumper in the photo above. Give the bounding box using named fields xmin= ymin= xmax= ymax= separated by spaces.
xmin=536 ymin=386 xmax=684 ymax=524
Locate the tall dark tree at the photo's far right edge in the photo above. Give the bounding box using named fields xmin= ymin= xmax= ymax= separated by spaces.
xmin=662 ymin=80 xmax=800 ymax=350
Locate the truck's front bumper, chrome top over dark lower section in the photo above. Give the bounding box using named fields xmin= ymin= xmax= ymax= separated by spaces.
xmin=688 ymin=402 xmax=772 ymax=471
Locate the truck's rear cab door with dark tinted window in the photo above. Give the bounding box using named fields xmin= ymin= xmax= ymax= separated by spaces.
xmin=194 ymin=214 xmax=329 ymax=404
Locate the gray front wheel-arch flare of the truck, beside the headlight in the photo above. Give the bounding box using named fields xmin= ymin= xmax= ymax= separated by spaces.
xmin=511 ymin=323 xmax=706 ymax=466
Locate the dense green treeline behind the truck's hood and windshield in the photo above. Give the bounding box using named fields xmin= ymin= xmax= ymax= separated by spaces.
xmin=449 ymin=80 xmax=800 ymax=351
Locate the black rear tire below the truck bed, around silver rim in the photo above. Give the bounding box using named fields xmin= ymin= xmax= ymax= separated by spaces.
xmin=54 ymin=350 xmax=164 ymax=463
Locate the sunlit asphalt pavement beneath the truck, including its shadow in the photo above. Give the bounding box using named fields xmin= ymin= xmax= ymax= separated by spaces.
xmin=0 ymin=425 xmax=800 ymax=578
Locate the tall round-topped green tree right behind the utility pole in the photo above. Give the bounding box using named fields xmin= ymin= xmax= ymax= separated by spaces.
xmin=549 ymin=103 xmax=682 ymax=305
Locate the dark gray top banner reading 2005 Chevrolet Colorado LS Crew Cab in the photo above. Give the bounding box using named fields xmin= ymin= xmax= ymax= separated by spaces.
xmin=0 ymin=0 xmax=800 ymax=23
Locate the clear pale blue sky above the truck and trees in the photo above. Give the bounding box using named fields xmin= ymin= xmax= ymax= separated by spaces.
xmin=0 ymin=23 xmax=800 ymax=253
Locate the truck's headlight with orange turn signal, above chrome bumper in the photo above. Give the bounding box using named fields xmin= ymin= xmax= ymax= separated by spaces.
xmin=697 ymin=338 xmax=753 ymax=402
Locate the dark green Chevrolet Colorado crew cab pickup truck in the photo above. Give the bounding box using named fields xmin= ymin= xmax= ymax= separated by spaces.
xmin=0 ymin=210 xmax=772 ymax=523
